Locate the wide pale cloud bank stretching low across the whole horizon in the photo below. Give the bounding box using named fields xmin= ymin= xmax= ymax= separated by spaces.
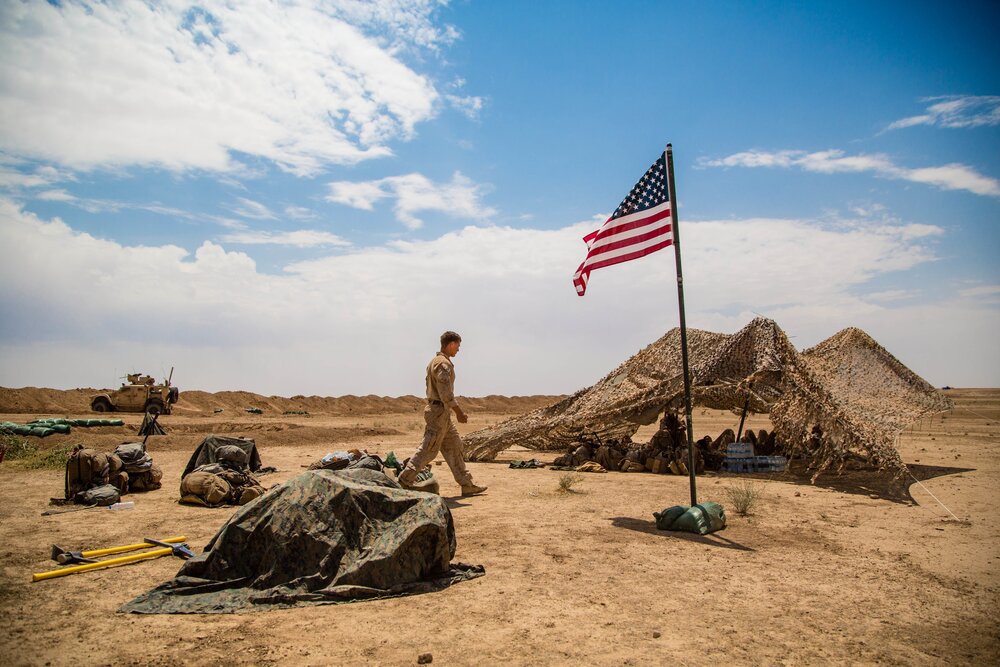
xmin=0 ymin=199 xmax=1000 ymax=395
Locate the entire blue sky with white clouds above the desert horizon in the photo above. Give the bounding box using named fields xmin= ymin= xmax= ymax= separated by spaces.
xmin=0 ymin=0 xmax=1000 ymax=395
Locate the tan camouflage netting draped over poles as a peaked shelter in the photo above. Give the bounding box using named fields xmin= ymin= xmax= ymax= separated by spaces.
xmin=464 ymin=317 xmax=950 ymax=479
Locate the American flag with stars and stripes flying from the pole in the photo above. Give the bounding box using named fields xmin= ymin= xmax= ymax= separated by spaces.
xmin=573 ymin=152 xmax=674 ymax=296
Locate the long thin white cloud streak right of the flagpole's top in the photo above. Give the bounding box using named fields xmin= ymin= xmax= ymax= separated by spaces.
xmin=698 ymin=150 xmax=1000 ymax=197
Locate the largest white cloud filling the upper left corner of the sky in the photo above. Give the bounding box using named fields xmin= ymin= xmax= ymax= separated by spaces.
xmin=0 ymin=0 xmax=456 ymax=174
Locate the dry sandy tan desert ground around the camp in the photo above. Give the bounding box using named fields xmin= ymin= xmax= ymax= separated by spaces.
xmin=0 ymin=389 xmax=1000 ymax=665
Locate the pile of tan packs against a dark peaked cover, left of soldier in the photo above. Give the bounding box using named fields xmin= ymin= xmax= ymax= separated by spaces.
xmin=180 ymin=435 xmax=264 ymax=507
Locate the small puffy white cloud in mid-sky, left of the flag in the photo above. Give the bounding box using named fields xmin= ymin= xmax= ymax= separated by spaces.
xmin=326 ymin=171 xmax=496 ymax=229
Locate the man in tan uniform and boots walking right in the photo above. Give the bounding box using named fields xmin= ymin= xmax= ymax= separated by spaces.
xmin=399 ymin=331 xmax=486 ymax=496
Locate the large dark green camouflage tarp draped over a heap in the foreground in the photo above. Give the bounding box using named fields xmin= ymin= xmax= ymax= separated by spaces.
xmin=120 ymin=469 xmax=483 ymax=614
